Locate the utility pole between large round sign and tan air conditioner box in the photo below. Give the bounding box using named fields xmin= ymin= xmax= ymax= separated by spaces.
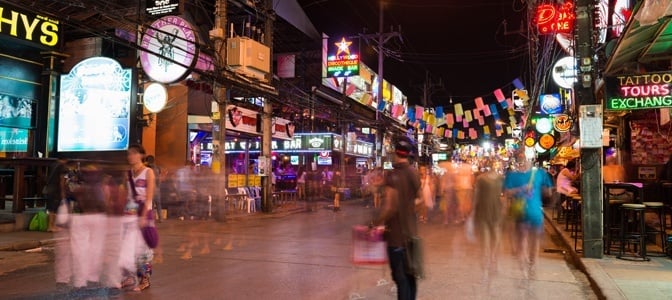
xmin=210 ymin=0 xmax=228 ymax=221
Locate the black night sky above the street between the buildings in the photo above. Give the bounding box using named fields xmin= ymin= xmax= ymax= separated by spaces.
xmin=299 ymin=0 xmax=528 ymax=106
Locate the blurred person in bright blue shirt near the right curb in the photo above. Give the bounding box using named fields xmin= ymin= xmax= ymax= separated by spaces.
xmin=503 ymin=151 xmax=553 ymax=278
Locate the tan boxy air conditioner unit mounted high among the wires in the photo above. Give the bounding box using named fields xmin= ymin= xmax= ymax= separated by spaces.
xmin=226 ymin=37 xmax=271 ymax=81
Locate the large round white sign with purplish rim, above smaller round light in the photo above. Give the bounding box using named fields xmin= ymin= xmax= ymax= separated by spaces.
xmin=140 ymin=16 xmax=196 ymax=83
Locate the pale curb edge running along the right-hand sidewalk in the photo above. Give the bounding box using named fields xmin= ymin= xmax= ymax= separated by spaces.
xmin=544 ymin=211 xmax=627 ymax=300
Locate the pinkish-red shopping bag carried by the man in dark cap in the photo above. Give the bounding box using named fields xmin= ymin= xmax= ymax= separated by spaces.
xmin=352 ymin=225 xmax=387 ymax=264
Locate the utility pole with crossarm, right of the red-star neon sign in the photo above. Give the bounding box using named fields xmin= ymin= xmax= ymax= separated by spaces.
xmin=360 ymin=0 xmax=401 ymax=167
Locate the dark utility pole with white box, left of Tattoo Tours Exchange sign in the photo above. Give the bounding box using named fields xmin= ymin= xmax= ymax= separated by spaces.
xmin=575 ymin=0 xmax=603 ymax=258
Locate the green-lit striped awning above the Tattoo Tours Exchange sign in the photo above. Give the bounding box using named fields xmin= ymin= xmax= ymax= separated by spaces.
xmin=604 ymin=0 xmax=672 ymax=76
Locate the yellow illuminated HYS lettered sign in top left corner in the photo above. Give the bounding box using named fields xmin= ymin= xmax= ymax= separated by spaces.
xmin=0 ymin=4 xmax=61 ymax=48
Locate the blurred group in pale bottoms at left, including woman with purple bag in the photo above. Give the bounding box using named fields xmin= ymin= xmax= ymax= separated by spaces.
xmin=46 ymin=145 xmax=158 ymax=291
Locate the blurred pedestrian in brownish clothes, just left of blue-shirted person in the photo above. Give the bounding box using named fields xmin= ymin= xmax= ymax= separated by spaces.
xmin=473 ymin=169 xmax=503 ymax=280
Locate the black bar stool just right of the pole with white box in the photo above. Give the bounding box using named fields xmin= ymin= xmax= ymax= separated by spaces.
xmin=616 ymin=203 xmax=649 ymax=261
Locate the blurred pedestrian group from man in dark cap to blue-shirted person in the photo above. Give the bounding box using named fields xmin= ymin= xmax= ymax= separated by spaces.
xmin=367 ymin=137 xmax=555 ymax=299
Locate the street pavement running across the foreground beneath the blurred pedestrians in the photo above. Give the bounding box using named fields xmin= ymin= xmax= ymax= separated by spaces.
xmin=0 ymin=203 xmax=596 ymax=299
